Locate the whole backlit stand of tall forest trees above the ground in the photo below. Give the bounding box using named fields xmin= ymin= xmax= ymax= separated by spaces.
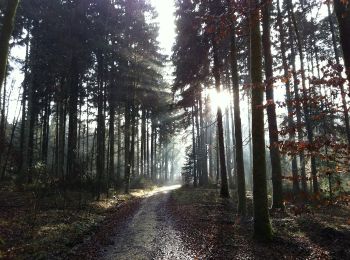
xmin=0 ymin=0 xmax=350 ymax=255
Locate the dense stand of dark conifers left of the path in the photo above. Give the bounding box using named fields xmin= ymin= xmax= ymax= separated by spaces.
xmin=1 ymin=1 xmax=185 ymax=197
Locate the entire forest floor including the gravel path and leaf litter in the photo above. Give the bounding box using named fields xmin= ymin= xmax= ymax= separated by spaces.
xmin=0 ymin=186 xmax=350 ymax=260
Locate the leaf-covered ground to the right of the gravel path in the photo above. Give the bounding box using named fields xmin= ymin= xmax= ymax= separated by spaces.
xmin=168 ymin=188 xmax=350 ymax=259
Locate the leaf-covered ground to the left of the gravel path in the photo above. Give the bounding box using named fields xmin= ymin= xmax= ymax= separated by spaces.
xmin=0 ymin=185 xmax=150 ymax=259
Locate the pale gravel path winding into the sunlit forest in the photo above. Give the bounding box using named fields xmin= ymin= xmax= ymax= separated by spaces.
xmin=103 ymin=186 xmax=194 ymax=260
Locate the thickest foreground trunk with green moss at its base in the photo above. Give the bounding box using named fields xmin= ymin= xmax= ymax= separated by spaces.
xmin=250 ymin=0 xmax=272 ymax=241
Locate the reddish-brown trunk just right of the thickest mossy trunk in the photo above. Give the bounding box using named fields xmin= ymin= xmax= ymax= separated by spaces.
xmin=263 ymin=0 xmax=284 ymax=208
